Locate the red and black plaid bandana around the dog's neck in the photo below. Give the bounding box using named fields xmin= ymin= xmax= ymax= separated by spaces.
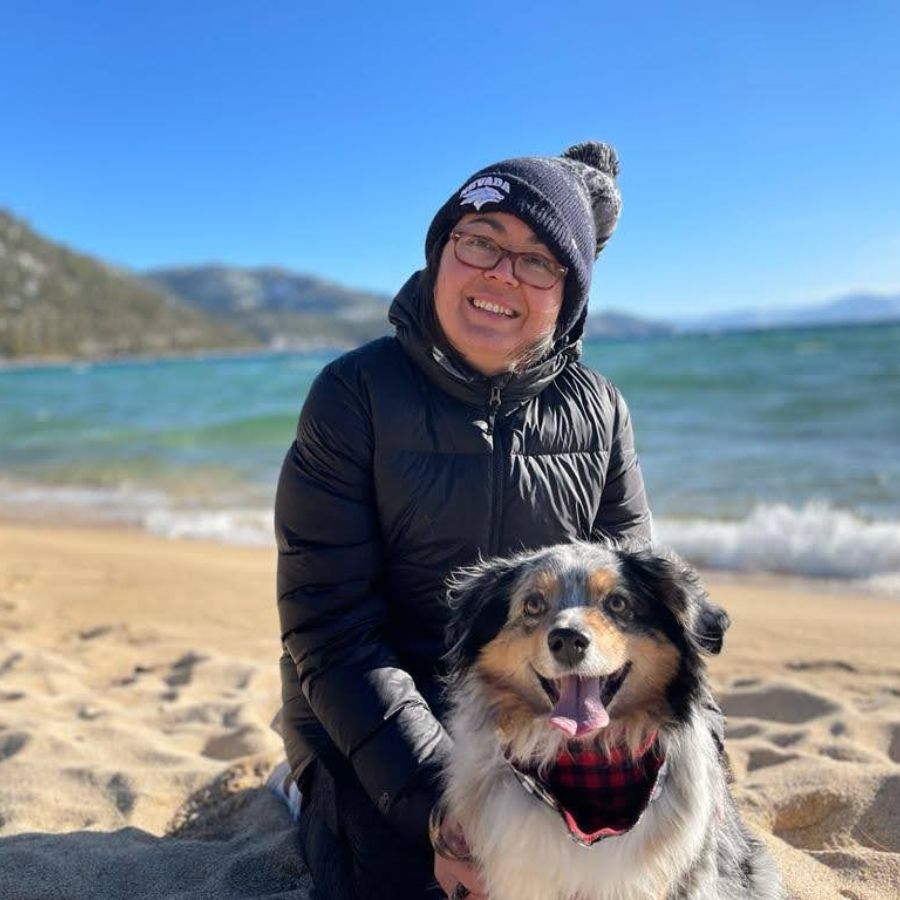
xmin=510 ymin=735 xmax=665 ymax=847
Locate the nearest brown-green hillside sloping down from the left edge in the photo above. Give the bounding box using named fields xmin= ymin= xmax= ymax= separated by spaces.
xmin=0 ymin=210 xmax=255 ymax=358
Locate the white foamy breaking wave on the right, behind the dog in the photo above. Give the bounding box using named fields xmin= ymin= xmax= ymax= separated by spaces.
xmin=654 ymin=503 xmax=900 ymax=588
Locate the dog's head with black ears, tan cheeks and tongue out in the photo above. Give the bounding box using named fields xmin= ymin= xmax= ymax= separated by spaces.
xmin=449 ymin=543 xmax=729 ymax=746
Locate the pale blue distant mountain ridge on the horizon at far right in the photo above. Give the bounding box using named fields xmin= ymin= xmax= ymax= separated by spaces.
xmin=675 ymin=293 xmax=900 ymax=331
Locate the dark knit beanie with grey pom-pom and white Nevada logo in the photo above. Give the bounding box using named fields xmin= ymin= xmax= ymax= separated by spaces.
xmin=425 ymin=141 xmax=622 ymax=336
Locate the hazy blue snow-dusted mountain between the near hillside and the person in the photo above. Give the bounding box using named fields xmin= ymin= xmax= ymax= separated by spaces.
xmin=144 ymin=265 xmax=390 ymax=347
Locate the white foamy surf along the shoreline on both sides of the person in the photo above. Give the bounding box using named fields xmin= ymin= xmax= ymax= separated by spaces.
xmin=0 ymin=479 xmax=900 ymax=596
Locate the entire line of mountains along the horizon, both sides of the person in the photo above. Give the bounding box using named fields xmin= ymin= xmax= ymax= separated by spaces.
xmin=21 ymin=210 xmax=884 ymax=358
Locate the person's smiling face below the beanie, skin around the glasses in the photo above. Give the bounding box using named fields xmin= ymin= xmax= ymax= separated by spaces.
xmin=434 ymin=212 xmax=565 ymax=375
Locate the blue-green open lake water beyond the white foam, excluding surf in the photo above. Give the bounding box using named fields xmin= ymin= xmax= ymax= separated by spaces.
xmin=0 ymin=324 xmax=900 ymax=520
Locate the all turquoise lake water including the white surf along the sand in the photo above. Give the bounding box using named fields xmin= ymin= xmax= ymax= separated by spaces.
xmin=0 ymin=324 xmax=900 ymax=592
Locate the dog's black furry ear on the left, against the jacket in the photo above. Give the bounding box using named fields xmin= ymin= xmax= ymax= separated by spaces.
xmin=447 ymin=559 xmax=519 ymax=672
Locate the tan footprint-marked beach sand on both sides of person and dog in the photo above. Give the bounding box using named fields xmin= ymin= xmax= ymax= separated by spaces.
xmin=0 ymin=524 xmax=900 ymax=900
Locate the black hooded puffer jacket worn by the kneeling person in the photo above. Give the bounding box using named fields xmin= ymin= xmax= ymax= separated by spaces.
xmin=275 ymin=275 xmax=650 ymax=840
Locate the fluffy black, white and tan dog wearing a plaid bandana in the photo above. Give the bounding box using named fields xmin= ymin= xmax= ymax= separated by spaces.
xmin=432 ymin=542 xmax=785 ymax=900
